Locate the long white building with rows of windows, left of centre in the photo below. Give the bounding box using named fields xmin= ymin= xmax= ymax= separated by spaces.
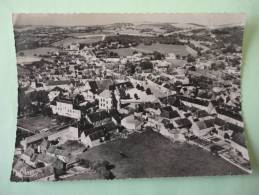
xmin=50 ymin=99 xmax=81 ymax=120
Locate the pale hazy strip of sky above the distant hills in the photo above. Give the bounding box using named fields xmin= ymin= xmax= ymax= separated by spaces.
xmin=13 ymin=13 xmax=247 ymax=26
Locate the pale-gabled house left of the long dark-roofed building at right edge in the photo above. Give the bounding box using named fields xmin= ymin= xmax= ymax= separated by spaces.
xmin=190 ymin=119 xmax=215 ymax=137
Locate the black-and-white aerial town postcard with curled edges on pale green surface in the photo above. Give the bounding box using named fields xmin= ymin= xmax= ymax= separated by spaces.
xmin=11 ymin=14 xmax=251 ymax=182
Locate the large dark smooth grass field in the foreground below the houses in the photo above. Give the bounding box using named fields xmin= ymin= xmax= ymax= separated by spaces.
xmin=77 ymin=131 xmax=244 ymax=179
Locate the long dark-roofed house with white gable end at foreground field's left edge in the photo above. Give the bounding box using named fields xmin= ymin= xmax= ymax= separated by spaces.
xmin=80 ymin=122 xmax=118 ymax=147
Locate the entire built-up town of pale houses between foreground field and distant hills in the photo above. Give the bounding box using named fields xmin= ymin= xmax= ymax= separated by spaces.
xmin=13 ymin=28 xmax=249 ymax=180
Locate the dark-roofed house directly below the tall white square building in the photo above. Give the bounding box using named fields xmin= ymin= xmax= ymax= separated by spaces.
xmin=85 ymin=110 xmax=112 ymax=127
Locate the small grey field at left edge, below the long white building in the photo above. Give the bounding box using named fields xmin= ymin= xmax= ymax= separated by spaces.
xmin=17 ymin=116 xmax=57 ymax=132
